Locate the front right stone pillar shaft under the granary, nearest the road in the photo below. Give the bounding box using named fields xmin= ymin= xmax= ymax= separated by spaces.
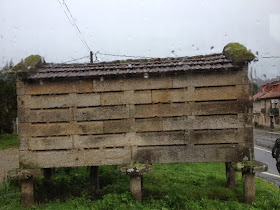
xmin=242 ymin=173 xmax=256 ymax=203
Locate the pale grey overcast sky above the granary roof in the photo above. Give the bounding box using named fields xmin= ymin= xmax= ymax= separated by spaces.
xmin=0 ymin=0 xmax=280 ymax=77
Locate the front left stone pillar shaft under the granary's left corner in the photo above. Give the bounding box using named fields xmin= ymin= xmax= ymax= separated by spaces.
xmin=21 ymin=177 xmax=34 ymax=208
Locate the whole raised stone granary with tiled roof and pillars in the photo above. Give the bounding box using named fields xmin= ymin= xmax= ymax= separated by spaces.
xmin=14 ymin=45 xmax=266 ymax=205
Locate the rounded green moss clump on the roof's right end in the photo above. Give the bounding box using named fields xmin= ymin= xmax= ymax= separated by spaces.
xmin=223 ymin=42 xmax=255 ymax=65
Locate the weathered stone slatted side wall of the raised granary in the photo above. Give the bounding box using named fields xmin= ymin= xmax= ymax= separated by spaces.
xmin=17 ymin=67 xmax=253 ymax=168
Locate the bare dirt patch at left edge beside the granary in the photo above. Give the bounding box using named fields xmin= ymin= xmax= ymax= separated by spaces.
xmin=0 ymin=148 xmax=19 ymax=184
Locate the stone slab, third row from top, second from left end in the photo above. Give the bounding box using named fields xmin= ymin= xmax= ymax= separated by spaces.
xmin=74 ymin=105 xmax=129 ymax=121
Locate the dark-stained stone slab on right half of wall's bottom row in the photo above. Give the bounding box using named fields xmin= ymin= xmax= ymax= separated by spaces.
xmin=133 ymin=144 xmax=253 ymax=163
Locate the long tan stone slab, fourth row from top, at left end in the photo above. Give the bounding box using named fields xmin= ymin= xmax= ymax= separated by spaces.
xmin=19 ymin=121 xmax=103 ymax=136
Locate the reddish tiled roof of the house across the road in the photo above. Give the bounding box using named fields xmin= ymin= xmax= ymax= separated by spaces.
xmin=253 ymin=81 xmax=280 ymax=100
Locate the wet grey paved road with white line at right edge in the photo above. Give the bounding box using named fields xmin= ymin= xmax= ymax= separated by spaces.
xmin=254 ymin=129 xmax=280 ymax=186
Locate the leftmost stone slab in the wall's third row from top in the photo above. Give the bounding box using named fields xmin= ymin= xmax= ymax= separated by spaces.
xmin=18 ymin=109 xmax=73 ymax=123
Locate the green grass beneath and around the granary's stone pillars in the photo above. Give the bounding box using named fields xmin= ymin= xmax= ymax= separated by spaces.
xmin=0 ymin=163 xmax=280 ymax=210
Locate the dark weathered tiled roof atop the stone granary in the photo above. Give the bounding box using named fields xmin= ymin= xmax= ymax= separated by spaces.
xmin=27 ymin=54 xmax=238 ymax=80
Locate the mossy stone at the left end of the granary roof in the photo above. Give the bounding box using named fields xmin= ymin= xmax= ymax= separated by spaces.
xmin=11 ymin=55 xmax=42 ymax=72
